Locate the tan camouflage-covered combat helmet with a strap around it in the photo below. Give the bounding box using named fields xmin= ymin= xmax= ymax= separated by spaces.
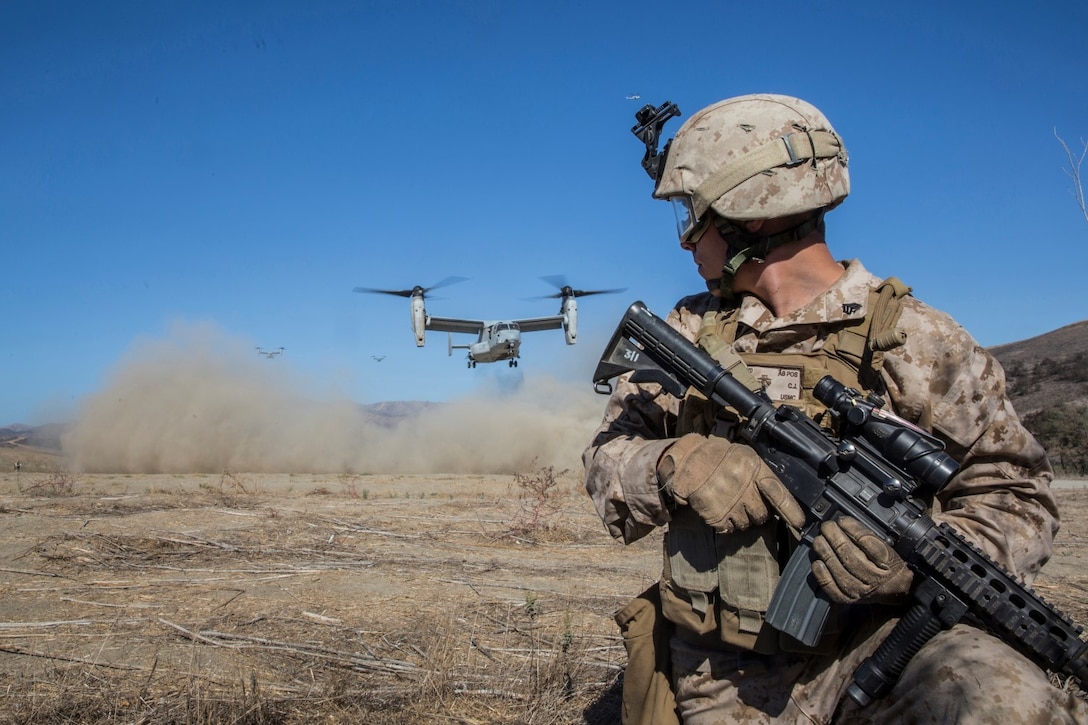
xmin=654 ymin=94 xmax=850 ymax=224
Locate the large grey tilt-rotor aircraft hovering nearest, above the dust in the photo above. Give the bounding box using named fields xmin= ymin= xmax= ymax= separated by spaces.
xmin=354 ymin=277 xmax=623 ymax=368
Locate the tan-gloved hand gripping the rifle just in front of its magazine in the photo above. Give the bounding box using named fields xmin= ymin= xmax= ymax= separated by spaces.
xmin=813 ymin=516 xmax=914 ymax=604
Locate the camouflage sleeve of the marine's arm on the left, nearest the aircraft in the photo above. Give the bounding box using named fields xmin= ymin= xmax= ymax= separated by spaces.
xmin=582 ymin=294 xmax=712 ymax=543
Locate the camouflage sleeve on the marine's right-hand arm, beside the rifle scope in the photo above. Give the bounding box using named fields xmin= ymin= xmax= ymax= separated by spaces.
xmin=883 ymin=297 xmax=1059 ymax=582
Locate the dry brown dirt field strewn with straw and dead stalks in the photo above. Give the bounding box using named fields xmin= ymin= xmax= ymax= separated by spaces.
xmin=0 ymin=459 xmax=1088 ymax=724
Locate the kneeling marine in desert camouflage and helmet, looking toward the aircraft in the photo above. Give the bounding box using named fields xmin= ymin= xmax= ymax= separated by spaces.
xmin=583 ymin=94 xmax=1088 ymax=725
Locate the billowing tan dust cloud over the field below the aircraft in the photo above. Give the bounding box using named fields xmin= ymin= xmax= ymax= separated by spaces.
xmin=62 ymin=323 xmax=605 ymax=474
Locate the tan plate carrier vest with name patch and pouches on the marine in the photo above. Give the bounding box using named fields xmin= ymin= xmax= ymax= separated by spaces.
xmin=662 ymin=278 xmax=911 ymax=654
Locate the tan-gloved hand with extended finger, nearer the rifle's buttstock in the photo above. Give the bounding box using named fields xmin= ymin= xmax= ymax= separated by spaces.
xmin=657 ymin=433 xmax=805 ymax=533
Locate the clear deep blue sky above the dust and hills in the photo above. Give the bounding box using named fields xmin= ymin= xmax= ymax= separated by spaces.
xmin=0 ymin=0 xmax=1088 ymax=425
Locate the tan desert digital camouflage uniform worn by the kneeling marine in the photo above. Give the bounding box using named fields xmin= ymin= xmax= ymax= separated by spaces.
xmin=583 ymin=261 xmax=1088 ymax=723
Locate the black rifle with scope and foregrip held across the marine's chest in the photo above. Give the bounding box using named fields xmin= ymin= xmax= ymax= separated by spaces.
xmin=593 ymin=302 xmax=1088 ymax=706
